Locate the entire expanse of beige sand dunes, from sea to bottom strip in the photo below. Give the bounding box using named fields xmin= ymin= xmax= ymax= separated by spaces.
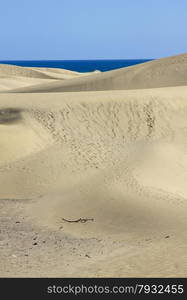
xmin=0 ymin=54 xmax=187 ymax=277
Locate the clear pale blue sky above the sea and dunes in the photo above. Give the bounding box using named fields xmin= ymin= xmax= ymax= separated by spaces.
xmin=0 ymin=0 xmax=187 ymax=60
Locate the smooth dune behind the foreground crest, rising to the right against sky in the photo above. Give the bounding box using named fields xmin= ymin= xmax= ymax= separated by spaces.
xmin=6 ymin=53 xmax=187 ymax=93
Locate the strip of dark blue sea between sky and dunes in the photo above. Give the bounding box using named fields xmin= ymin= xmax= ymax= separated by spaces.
xmin=0 ymin=59 xmax=151 ymax=72
